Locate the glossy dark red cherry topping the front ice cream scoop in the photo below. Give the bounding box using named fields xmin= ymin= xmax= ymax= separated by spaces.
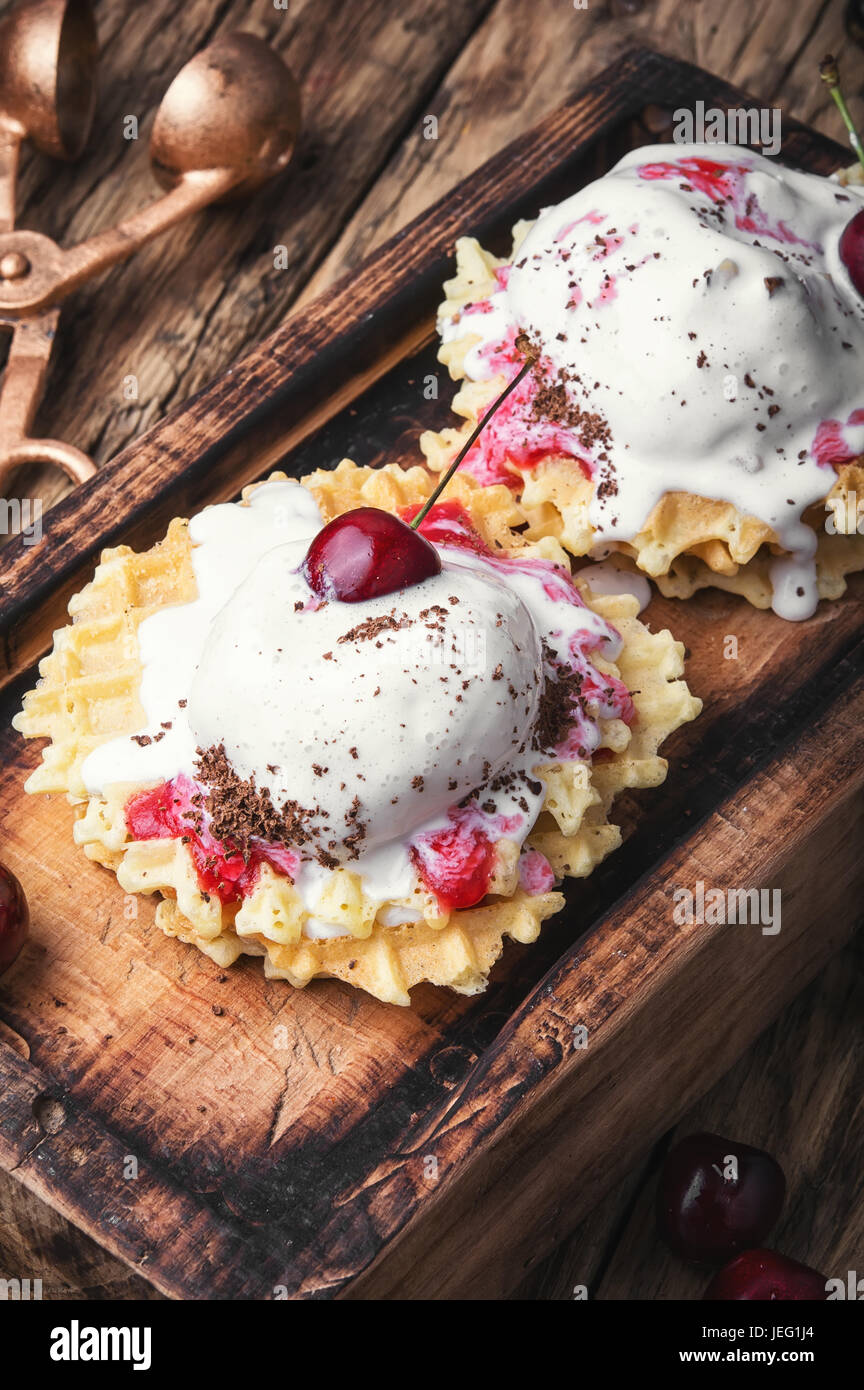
xmin=303 ymin=507 xmax=440 ymax=603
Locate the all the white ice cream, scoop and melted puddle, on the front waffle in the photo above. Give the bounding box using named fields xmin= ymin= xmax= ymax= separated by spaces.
xmin=82 ymin=481 xmax=632 ymax=935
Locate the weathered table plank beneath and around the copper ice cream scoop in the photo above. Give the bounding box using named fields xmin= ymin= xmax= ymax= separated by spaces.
xmin=0 ymin=0 xmax=489 ymax=517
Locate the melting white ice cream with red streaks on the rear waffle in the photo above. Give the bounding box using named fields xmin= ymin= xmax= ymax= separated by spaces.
xmin=439 ymin=145 xmax=864 ymax=619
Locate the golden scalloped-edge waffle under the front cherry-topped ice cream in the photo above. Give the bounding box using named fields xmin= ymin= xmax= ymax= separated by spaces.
xmin=14 ymin=460 xmax=701 ymax=1005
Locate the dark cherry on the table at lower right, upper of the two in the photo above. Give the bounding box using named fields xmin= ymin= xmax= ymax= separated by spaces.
xmin=657 ymin=1134 xmax=786 ymax=1265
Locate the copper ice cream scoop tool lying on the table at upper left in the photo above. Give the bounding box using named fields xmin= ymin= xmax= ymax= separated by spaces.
xmin=0 ymin=0 xmax=300 ymax=493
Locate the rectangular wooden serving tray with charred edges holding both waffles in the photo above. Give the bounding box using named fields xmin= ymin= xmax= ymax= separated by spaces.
xmin=0 ymin=50 xmax=864 ymax=1298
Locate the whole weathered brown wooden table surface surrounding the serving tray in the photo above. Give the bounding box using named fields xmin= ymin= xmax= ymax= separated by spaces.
xmin=0 ymin=0 xmax=864 ymax=1298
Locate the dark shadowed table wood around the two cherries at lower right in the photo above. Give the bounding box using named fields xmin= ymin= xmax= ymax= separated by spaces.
xmin=515 ymin=934 xmax=864 ymax=1301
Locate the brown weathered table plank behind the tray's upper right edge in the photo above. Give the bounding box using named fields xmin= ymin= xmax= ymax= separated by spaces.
xmin=299 ymin=0 xmax=864 ymax=303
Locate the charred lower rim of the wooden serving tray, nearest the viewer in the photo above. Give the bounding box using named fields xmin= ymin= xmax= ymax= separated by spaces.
xmin=0 ymin=653 xmax=864 ymax=1300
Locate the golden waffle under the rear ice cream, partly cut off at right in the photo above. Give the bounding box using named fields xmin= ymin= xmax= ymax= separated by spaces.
xmin=419 ymin=230 xmax=864 ymax=607
